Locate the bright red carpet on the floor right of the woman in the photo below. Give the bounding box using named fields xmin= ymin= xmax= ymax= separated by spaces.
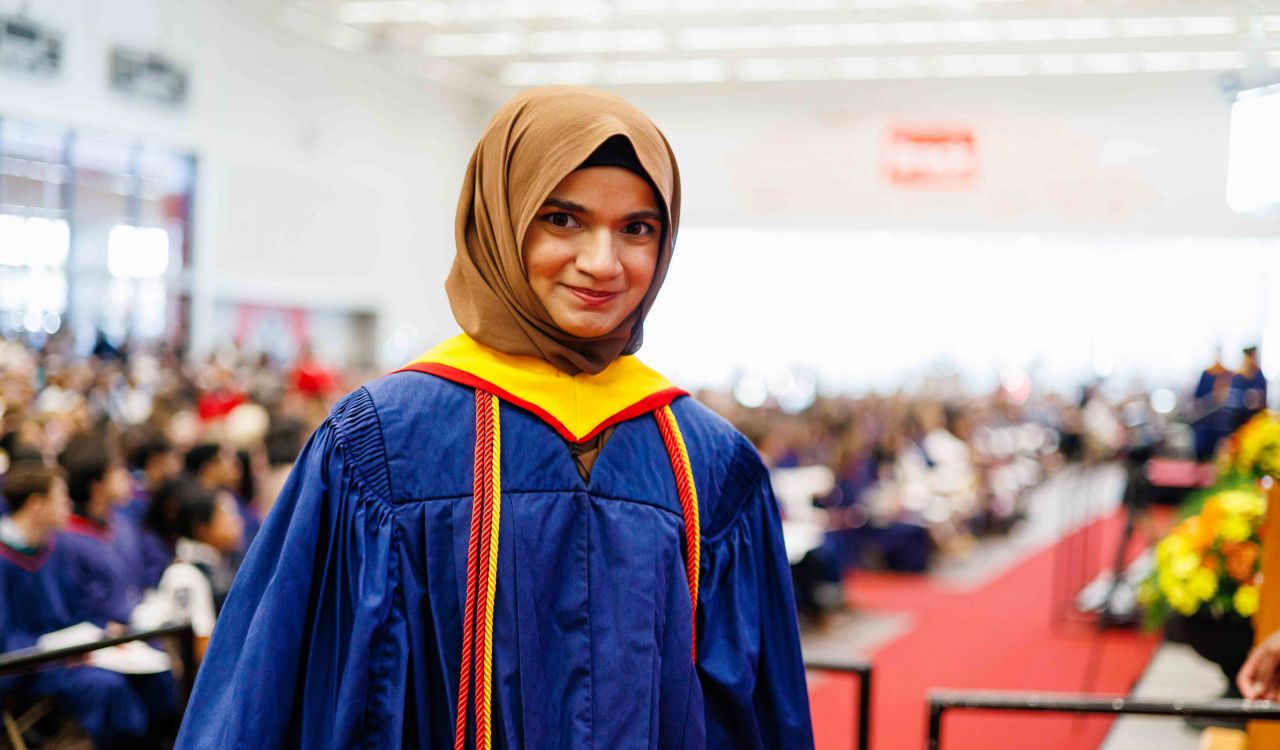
xmin=809 ymin=513 xmax=1160 ymax=750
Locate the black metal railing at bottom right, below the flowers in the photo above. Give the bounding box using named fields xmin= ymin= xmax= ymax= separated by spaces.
xmin=928 ymin=691 xmax=1280 ymax=750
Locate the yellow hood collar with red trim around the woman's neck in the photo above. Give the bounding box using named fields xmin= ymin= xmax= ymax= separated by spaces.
xmin=402 ymin=334 xmax=687 ymax=443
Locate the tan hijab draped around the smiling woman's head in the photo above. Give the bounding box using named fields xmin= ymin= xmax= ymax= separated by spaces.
xmin=444 ymin=86 xmax=680 ymax=375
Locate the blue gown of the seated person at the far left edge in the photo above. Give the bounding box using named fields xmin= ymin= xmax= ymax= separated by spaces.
xmin=0 ymin=541 xmax=153 ymax=747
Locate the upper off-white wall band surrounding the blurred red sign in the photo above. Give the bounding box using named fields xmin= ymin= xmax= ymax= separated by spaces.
xmin=631 ymin=73 xmax=1280 ymax=237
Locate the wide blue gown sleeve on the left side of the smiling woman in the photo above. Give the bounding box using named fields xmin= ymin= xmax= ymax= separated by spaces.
xmin=177 ymin=390 xmax=408 ymax=750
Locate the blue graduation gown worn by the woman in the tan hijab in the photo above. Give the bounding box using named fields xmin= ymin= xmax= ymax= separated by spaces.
xmin=178 ymin=372 xmax=813 ymax=750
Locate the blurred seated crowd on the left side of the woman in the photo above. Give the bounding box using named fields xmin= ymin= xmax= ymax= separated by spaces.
xmin=0 ymin=337 xmax=369 ymax=747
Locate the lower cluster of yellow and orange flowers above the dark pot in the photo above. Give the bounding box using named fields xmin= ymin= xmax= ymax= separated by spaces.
xmin=1138 ymin=484 xmax=1266 ymax=627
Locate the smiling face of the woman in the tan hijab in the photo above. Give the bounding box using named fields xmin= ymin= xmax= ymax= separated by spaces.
xmin=521 ymin=166 xmax=662 ymax=338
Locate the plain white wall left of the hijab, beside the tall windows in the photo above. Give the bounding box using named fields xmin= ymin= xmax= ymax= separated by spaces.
xmin=0 ymin=0 xmax=488 ymax=366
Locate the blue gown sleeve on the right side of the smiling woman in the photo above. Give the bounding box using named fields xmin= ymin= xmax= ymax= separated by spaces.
xmin=698 ymin=440 xmax=813 ymax=750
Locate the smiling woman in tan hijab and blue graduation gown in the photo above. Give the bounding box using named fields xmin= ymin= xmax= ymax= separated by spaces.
xmin=178 ymin=88 xmax=813 ymax=749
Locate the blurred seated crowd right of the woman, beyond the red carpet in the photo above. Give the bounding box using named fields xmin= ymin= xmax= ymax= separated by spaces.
xmin=699 ymin=378 xmax=1169 ymax=619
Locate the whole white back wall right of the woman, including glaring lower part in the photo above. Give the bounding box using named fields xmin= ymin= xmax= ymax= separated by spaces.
xmin=630 ymin=74 xmax=1280 ymax=389
